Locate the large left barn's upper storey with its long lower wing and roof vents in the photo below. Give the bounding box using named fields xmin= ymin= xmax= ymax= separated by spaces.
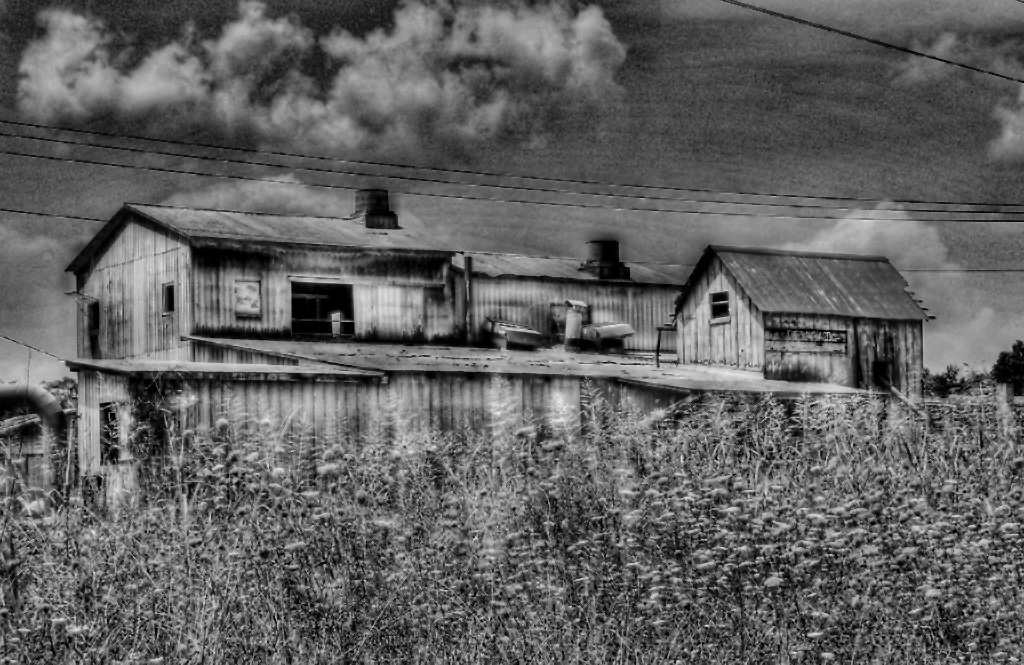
xmin=68 ymin=190 xmax=683 ymax=361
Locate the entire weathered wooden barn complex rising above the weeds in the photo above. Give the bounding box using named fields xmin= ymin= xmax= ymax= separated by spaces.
xmin=59 ymin=190 xmax=924 ymax=504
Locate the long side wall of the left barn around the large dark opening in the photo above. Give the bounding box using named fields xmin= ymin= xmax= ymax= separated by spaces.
xmin=194 ymin=248 xmax=454 ymax=341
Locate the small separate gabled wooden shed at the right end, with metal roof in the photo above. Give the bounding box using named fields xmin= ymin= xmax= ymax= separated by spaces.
xmin=676 ymin=245 xmax=929 ymax=398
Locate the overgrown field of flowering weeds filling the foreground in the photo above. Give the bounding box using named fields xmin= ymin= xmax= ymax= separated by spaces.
xmin=0 ymin=387 xmax=1024 ymax=664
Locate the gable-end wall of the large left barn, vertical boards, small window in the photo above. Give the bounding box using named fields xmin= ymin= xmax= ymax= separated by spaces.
xmin=77 ymin=215 xmax=191 ymax=360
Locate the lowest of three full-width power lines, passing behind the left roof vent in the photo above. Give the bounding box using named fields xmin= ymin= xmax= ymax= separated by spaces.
xmin=6 ymin=145 xmax=1024 ymax=223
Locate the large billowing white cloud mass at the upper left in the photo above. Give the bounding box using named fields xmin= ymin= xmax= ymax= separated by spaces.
xmin=18 ymin=0 xmax=626 ymax=154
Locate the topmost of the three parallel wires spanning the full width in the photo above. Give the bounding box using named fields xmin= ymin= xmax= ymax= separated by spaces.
xmin=6 ymin=116 xmax=1024 ymax=207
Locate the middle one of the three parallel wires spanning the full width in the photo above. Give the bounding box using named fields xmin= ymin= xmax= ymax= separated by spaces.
xmin=8 ymin=130 xmax=1024 ymax=214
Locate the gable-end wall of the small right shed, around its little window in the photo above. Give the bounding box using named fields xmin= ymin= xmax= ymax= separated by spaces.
xmin=676 ymin=257 xmax=765 ymax=369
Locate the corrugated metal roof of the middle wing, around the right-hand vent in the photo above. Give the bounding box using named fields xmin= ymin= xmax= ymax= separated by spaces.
xmin=454 ymin=252 xmax=688 ymax=287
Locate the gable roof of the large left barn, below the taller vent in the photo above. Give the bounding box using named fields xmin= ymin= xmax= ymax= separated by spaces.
xmin=67 ymin=203 xmax=454 ymax=273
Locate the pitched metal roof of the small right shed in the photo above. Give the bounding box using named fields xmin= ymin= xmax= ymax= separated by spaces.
xmin=685 ymin=245 xmax=929 ymax=321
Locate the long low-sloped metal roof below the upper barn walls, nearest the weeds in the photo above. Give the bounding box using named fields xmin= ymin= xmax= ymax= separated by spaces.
xmin=188 ymin=337 xmax=862 ymax=394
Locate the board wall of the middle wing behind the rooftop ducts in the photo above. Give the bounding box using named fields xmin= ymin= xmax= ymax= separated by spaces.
xmin=455 ymin=274 xmax=680 ymax=354
